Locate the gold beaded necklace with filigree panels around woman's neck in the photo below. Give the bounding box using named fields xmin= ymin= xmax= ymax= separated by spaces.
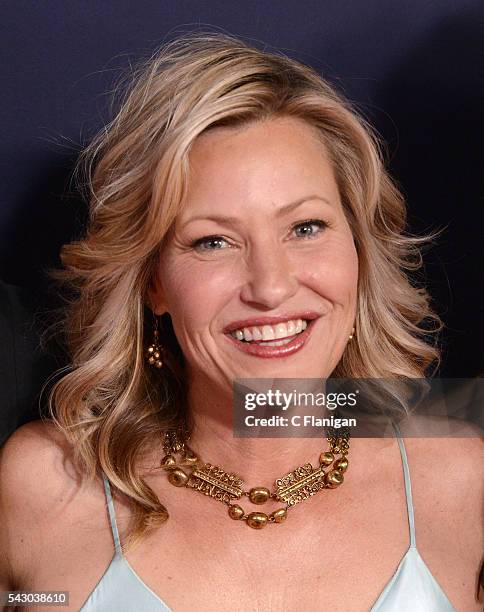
xmin=160 ymin=428 xmax=349 ymax=529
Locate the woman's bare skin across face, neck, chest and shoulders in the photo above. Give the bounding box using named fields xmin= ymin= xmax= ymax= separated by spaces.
xmin=0 ymin=119 xmax=484 ymax=612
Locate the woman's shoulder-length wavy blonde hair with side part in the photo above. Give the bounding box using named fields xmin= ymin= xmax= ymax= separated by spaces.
xmin=50 ymin=33 xmax=439 ymax=546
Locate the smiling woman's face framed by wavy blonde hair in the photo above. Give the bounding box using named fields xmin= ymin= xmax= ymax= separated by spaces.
xmin=150 ymin=118 xmax=358 ymax=388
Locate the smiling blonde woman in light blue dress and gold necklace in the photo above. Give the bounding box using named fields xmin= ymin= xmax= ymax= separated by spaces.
xmin=1 ymin=35 xmax=480 ymax=612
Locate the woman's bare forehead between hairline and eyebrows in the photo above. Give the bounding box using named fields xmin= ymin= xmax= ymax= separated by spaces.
xmin=181 ymin=117 xmax=339 ymax=216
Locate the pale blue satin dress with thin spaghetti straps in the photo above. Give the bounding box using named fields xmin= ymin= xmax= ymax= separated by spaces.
xmin=81 ymin=425 xmax=455 ymax=612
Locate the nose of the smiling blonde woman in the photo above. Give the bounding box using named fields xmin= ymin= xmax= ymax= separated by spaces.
xmin=240 ymin=242 xmax=298 ymax=310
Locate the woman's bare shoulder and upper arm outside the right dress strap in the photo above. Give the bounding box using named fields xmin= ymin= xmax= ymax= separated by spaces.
xmin=405 ymin=422 xmax=484 ymax=610
